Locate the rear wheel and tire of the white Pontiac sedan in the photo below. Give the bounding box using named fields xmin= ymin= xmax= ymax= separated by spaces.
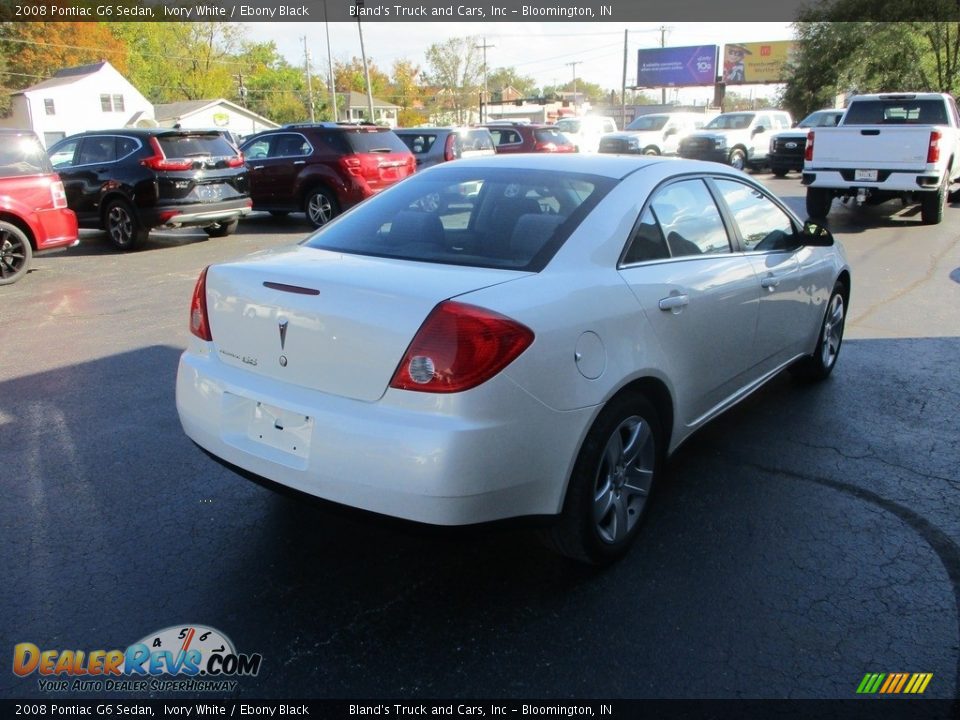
xmin=543 ymin=393 xmax=663 ymax=565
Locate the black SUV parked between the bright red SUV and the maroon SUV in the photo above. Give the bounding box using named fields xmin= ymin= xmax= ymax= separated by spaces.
xmin=49 ymin=128 xmax=251 ymax=250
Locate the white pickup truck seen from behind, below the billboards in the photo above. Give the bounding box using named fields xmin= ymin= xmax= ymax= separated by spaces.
xmin=803 ymin=93 xmax=960 ymax=225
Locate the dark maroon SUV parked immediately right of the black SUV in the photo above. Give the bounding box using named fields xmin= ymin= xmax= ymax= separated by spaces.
xmin=241 ymin=123 xmax=416 ymax=227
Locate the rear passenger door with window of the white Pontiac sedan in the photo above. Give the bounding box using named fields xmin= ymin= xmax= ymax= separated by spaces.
xmin=620 ymin=179 xmax=759 ymax=426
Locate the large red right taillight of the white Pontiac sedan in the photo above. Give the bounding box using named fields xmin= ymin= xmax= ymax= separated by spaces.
xmin=390 ymin=300 xmax=534 ymax=393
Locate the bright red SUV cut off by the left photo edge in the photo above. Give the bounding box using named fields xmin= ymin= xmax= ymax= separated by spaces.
xmin=0 ymin=129 xmax=77 ymax=285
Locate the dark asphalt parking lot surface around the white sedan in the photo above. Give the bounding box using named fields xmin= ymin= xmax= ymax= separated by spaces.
xmin=0 ymin=175 xmax=960 ymax=699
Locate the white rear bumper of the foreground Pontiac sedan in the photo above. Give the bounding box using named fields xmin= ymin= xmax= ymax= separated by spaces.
xmin=177 ymin=339 xmax=593 ymax=525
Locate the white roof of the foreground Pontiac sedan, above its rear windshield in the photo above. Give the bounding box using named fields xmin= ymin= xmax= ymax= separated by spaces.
xmin=424 ymin=153 xmax=742 ymax=180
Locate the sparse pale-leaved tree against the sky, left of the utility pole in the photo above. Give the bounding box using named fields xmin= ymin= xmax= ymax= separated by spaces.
xmin=426 ymin=37 xmax=483 ymax=125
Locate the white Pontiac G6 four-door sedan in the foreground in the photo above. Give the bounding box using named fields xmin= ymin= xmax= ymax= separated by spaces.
xmin=177 ymin=155 xmax=850 ymax=563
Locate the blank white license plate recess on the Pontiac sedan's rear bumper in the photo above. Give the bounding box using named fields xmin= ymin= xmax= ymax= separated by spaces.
xmin=223 ymin=393 xmax=314 ymax=467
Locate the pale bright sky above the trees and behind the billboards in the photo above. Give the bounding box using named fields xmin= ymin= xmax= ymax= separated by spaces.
xmin=247 ymin=21 xmax=792 ymax=102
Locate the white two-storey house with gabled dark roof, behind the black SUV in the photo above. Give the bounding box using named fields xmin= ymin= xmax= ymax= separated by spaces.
xmin=0 ymin=60 xmax=156 ymax=147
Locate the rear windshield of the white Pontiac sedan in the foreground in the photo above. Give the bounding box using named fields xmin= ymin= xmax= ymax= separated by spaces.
xmin=304 ymin=166 xmax=616 ymax=272
